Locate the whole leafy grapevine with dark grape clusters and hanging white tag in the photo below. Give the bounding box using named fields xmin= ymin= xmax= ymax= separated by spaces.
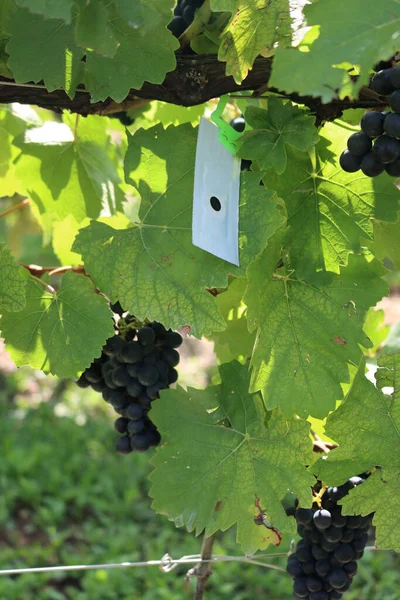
xmin=0 ymin=0 xmax=400 ymax=600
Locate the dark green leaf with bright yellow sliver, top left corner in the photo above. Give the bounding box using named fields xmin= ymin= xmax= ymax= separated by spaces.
xmin=6 ymin=8 xmax=83 ymax=98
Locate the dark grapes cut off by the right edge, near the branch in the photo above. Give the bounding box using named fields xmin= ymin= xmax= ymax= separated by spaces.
xmin=339 ymin=65 xmax=400 ymax=177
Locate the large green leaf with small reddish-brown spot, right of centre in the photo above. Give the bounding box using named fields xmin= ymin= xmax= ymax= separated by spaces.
xmin=244 ymin=247 xmax=387 ymax=418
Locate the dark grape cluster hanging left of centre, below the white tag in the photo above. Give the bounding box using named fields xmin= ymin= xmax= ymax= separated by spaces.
xmin=77 ymin=310 xmax=182 ymax=454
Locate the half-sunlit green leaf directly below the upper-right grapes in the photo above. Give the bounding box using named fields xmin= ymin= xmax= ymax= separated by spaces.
xmin=263 ymin=123 xmax=400 ymax=277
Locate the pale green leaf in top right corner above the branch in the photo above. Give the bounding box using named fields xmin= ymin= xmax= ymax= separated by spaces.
xmin=269 ymin=0 xmax=400 ymax=102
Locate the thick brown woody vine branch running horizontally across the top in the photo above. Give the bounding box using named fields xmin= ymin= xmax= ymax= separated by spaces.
xmin=0 ymin=57 xmax=388 ymax=124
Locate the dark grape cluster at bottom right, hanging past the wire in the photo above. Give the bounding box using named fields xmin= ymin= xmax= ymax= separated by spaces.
xmin=287 ymin=477 xmax=372 ymax=600
